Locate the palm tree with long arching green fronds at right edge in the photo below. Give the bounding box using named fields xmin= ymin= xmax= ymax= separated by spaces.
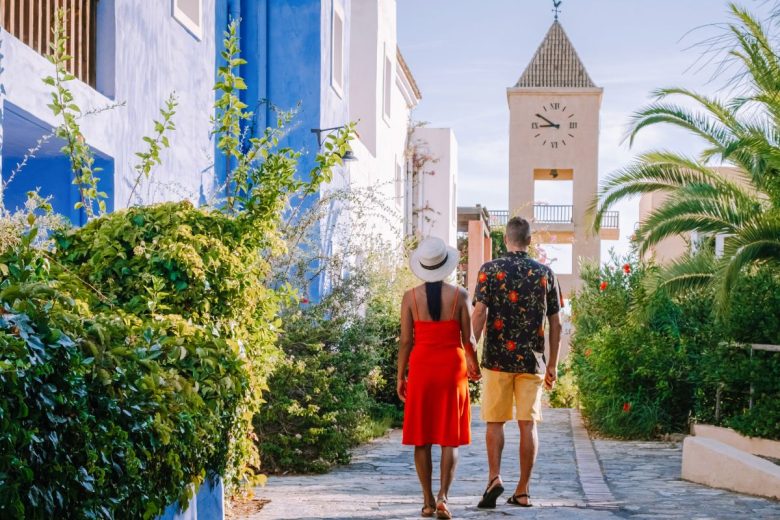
xmin=591 ymin=4 xmax=780 ymax=309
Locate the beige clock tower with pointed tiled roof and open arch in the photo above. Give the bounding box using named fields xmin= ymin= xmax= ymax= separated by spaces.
xmin=507 ymin=17 xmax=618 ymax=297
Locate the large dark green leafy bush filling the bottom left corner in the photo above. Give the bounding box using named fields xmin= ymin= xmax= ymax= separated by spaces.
xmin=0 ymin=229 xmax=249 ymax=518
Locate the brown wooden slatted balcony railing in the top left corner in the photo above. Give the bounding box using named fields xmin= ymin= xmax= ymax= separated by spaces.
xmin=0 ymin=0 xmax=98 ymax=87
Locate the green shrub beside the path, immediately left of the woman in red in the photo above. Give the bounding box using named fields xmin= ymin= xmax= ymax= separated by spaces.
xmin=255 ymin=296 xmax=397 ymax=473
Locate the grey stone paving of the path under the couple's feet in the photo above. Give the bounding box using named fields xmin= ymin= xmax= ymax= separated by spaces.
xmin=244 ymin=407 xmax=780 ymax=520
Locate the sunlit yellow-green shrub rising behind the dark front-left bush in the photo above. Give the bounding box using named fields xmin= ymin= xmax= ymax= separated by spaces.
xmin=55 ymin=201 xmax=281 ymax=490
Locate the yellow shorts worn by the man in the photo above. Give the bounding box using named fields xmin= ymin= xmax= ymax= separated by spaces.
xmin=481 ymin=369 xmax=544 ymax=422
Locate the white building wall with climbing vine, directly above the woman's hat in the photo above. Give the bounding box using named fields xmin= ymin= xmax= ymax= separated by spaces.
xmin=412 ymin=127 xmax=458 ymax=247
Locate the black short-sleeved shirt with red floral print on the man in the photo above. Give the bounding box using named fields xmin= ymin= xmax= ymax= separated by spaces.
xmin=474 ymin=252 xmax=563 ymax=374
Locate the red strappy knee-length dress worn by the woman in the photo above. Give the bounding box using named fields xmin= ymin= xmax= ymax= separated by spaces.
xmin=402 ymin=291 xmax=471 ymax=446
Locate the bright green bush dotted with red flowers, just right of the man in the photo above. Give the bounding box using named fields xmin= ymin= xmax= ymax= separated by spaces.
xmin=571 ymin=260 xmax=713 ymax=438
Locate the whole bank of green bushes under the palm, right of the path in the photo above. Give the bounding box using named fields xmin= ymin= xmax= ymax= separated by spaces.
xmin=571 ymin=255 xmax=780 ymax=438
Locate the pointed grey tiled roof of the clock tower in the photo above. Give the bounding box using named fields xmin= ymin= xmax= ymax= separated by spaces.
xmin=515 ymin=20 xmax=596 ymax=88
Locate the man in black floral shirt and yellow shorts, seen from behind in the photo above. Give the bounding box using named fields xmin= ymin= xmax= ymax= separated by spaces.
xmin=472 ymin=217 xmax=563 ymax=508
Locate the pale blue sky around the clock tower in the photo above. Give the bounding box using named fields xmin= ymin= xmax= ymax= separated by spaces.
xmin=397 ymin=0 xmax=771 ymax=259
